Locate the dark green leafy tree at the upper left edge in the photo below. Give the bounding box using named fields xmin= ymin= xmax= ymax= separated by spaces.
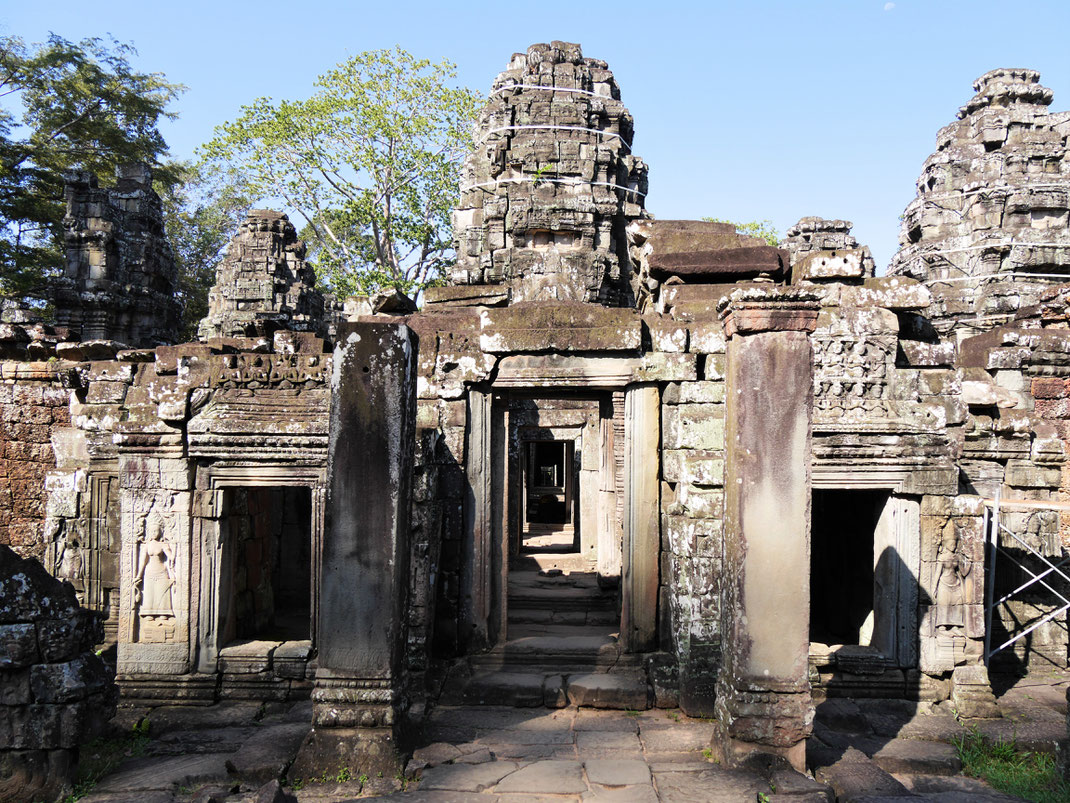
xmin=0 ymin=34 xmax=184 ymax=294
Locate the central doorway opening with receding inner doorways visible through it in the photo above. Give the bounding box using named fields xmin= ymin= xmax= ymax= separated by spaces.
xmin=506 ymin=396 xmax=621 ymax=661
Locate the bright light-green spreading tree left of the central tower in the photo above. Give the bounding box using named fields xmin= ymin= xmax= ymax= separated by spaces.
xmin=203 ymin=48 xmax=479 ymax=296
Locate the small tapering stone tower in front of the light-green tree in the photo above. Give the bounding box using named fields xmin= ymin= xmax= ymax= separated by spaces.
xmin=197 ymin=209 xmax=324 ymax=340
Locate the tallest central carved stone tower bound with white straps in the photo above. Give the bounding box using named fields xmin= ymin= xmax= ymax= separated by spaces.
xmin=450 ymin=42 xmax=646 ymax=306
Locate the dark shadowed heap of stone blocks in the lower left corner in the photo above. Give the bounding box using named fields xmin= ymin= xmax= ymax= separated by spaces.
xmin=0 ymin=546 xmax=117 ymax=801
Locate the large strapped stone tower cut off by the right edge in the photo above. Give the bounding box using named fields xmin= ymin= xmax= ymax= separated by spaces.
xmin=889 ymin=70 xmax=1070 ymax=334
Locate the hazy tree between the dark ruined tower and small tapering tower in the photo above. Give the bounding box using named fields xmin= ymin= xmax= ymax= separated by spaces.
xmin=157 ymin=165 xmax=253 ymax=340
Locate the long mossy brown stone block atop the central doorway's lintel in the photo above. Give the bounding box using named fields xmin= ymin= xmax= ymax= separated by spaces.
xmin=479 ymin=301 xmax=642 ymax=353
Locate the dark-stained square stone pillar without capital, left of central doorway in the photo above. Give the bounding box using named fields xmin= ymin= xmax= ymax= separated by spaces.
xmin=293 ymin=323 xmax=416 ymax=777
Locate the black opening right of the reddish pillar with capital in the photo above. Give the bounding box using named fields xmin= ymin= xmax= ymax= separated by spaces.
xmin=810 ymin=489 xmax=889 ymax=645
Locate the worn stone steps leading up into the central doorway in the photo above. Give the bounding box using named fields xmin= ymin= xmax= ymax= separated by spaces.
xmin=442 ymin=551 xmax=653 ymax=710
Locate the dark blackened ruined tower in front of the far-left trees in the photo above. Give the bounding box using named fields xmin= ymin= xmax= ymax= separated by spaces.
xmin=52 ymin=165 xmax=182 ymax=348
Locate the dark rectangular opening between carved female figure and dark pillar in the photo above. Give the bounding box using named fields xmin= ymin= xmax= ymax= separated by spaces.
xmin=219 ymin=486 xmax=312 ymax=645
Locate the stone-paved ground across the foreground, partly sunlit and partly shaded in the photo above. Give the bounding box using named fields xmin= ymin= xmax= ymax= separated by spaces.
xmin=82 ymin=672 xmax=1070 ymax=803
